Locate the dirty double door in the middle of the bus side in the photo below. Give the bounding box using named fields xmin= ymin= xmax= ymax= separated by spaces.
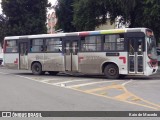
xmin=65 ymin=40 xmax=78 ymax=71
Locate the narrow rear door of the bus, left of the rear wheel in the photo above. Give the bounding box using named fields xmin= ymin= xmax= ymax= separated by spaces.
xmin=19 ymin=42 xmax=28 ymax=69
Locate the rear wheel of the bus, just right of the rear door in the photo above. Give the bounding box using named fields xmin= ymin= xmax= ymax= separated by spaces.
xmin=32 ymin=62 xmax=44 ymax=75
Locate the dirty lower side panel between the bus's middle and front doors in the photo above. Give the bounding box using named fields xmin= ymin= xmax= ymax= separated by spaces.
xmin=79 ymin=52 xmax=127 ymax=74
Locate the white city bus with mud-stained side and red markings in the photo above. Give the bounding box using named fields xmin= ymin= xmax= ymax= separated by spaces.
xmin=3 ymin=28 xmax=158 ymax=79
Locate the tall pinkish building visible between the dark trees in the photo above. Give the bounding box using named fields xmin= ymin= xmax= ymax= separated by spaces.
xmin=47 ymin=10 xmax=57 ymax=34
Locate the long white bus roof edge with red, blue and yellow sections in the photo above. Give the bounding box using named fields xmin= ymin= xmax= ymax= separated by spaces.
xmin=4 ymin=28 xmax=147 ymax=40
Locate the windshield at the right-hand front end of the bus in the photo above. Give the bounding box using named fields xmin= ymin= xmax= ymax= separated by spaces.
xmin=147 ymin=36 xmax=157 ymax=60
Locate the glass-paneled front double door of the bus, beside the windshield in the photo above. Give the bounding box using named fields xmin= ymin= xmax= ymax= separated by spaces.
xmin=128 ymin=37 xmax=144 ymax=74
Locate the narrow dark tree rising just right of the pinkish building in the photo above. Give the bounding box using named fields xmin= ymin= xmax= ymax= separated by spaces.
xmin=55 ymin=0 xmax=76 ymax=32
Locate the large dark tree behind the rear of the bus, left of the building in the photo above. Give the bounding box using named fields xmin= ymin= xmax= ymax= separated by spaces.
xmin=2 ymin=0 xmax=48 ymax=35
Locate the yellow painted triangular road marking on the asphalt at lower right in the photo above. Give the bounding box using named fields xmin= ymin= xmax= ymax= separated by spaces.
xmin=70 ymin=80 xmax=160 ymax=110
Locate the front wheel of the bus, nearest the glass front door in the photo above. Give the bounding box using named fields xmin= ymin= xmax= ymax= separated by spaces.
xmin=104 ymin=64 xmax=119 ymax=79
